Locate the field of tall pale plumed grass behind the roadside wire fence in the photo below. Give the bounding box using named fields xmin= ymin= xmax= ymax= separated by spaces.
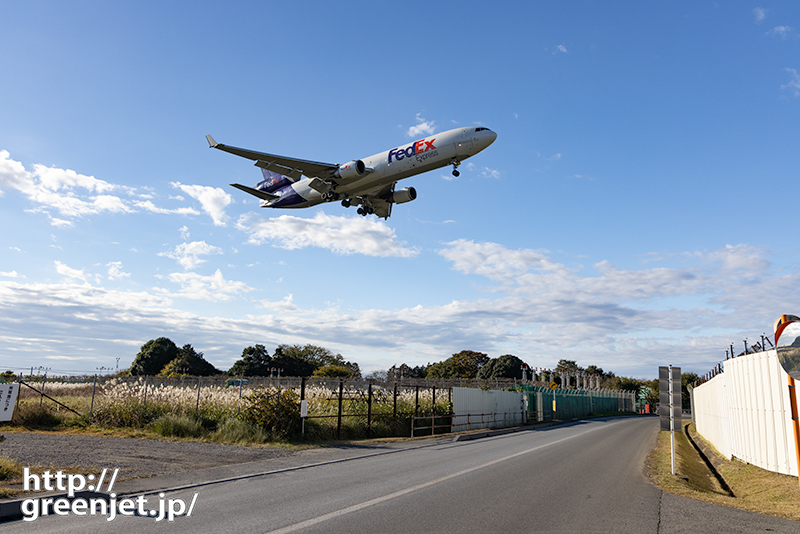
xmin=3 ymin=378 xmax=451 ymax=443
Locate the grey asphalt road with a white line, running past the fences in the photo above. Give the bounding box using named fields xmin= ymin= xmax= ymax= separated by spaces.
xmin=2 ymin=418 xmax=800 ymax=534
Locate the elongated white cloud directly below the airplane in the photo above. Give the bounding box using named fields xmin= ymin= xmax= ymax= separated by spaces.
xmin=236 ymin=212 xmax=419 ymax=258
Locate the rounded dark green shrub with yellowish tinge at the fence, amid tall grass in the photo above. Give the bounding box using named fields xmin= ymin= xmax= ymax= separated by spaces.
xmin=239 ymin=386 xmax=300 ymax=438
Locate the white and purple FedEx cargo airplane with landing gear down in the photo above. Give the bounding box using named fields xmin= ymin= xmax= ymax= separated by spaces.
xmin=206 ymin=126 xmax=497 ymax=219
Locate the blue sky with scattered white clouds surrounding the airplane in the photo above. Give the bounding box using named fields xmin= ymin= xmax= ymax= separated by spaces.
xmin=0 ymin=1 xmax=800 ymax=378
